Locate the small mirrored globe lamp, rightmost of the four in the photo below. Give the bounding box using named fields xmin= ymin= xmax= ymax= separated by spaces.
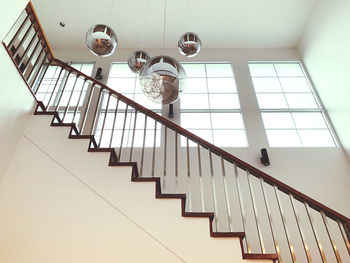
xmin=178 ymin=32 xmax=202 ymax=57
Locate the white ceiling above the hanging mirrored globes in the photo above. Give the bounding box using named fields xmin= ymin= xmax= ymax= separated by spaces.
xmin=32 ymin=0 xmax=319 ymax=49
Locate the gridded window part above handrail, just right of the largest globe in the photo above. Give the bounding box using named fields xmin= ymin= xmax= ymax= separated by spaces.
xmin=180 ymin=63 xmax=247 ymax=147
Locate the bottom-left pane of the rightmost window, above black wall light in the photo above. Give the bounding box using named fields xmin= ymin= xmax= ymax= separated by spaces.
xmin=266 ymin=130 xmax=301 ymax=147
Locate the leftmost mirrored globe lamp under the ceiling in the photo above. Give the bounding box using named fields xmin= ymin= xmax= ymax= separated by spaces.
xmin=85 ymin=24 xmax=118 ymax=57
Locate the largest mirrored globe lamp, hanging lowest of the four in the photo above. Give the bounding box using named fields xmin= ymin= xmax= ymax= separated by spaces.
xmin=140 ymin=56 xmax=186 ymax=104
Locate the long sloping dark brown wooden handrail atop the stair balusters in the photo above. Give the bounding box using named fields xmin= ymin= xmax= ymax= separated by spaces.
xmin=52 ymin=58 xmax=350 ymax=229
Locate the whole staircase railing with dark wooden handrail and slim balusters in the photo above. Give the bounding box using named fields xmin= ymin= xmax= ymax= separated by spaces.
xmin=3 ymin=1 xmax=350 ymax=262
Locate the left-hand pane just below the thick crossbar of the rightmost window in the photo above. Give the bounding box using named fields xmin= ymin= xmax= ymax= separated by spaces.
xmin=261 ymin=112 xmax=295 ymax=129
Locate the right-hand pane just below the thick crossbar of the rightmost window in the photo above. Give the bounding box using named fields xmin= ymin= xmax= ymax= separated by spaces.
xmin=292 ymin=112 xmax=328 ymax=129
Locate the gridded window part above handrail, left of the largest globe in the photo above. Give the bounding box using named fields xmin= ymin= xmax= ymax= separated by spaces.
xmin=107 ymin=63 xmax=162 ymax=113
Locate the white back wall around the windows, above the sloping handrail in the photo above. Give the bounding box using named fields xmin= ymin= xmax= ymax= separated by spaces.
xmin=54 ymin=49 xmax=350 ymax=219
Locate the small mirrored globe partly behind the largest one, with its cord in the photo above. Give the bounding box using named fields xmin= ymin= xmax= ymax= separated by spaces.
xmin=128 ymin=0 xmax=151 ymax=73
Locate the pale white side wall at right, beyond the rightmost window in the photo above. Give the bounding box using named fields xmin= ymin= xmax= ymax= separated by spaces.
xmin=298 ymin=0 xmax=350 ymax=159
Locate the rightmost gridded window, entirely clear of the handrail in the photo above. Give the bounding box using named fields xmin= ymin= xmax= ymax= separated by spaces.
xmin=249 ymin=62 xmax=336 ymax=147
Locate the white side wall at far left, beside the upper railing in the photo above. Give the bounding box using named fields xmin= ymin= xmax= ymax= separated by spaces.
xmin=0 ymin=0 xmax=34 ymax=182
